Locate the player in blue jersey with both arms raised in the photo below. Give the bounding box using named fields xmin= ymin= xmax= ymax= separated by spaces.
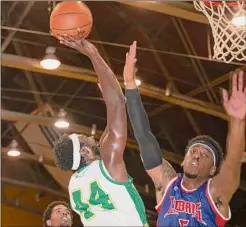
xmin=124 ymin=43 xmax=246 ymax=227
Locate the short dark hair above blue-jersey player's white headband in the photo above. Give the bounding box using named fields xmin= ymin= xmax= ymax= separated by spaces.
xmin=185 ymin=135 xmax=224 ymax=169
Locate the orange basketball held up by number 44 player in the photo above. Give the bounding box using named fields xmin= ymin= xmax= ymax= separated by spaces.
xmin=50 ymin=2 xmax=93 ymax=38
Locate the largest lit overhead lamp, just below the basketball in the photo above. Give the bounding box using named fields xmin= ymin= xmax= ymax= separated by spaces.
xmin=40 ymin=46 xmax=61 ymax=70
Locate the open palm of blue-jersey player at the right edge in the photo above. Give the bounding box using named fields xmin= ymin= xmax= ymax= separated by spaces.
xmin=222 ymin=71 xmax=246 ymax=120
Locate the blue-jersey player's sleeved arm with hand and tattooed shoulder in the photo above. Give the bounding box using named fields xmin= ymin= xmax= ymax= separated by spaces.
xmin=124 ymin=42 xmax=176 ymax=203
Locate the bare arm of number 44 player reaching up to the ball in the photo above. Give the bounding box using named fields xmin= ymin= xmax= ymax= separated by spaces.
xmin=60 ymin=36 xmax=128 ymax=181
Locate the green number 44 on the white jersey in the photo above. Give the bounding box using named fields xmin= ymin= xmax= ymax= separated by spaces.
xmin=72 ymin=181 xmax=115 ymax=220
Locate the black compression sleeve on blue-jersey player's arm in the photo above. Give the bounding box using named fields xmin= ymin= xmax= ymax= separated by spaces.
xmin=125 ymin=89 xmax=162 ymax=170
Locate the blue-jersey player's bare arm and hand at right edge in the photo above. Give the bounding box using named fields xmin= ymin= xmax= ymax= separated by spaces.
xmin=210 ymin=72 xmax=246 ymax=215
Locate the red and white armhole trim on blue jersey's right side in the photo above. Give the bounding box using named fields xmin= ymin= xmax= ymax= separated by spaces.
xmin=206 ymin=179 xmax=231 ymax=227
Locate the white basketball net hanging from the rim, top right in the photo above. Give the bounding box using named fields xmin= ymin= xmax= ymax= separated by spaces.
xmin=193 ymin=1 xmax=246 ymax=63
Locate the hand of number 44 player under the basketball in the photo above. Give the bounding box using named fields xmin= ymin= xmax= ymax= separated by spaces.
xmin=59 ymin=29 xmax=98 ymax=56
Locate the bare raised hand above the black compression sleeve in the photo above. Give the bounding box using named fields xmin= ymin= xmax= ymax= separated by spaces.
xmin=123 ymin=41 xmax=137 ymax=89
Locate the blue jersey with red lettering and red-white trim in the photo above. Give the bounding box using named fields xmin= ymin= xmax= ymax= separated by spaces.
xmin=156 ymin=174 xmax=231 ymax=227
